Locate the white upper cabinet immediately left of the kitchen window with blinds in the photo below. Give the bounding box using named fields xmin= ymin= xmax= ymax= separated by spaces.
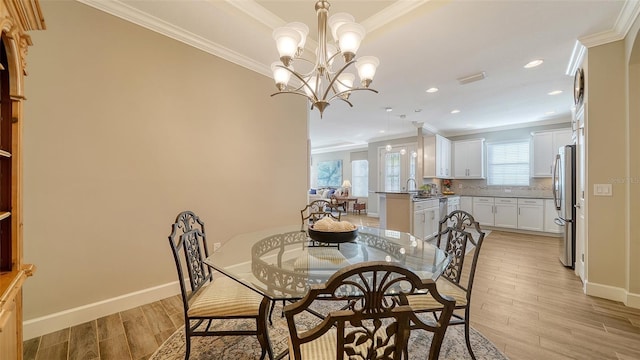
xmin=453 ymin=139 xmax=485 ymax=179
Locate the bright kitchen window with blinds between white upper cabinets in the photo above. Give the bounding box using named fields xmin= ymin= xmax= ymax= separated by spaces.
xmin=487 ymin=140 xmax=529 ymax=186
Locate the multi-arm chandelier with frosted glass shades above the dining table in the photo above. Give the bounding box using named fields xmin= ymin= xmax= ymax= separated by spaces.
xmin=271 ymin=0 xmax=379 ymax=118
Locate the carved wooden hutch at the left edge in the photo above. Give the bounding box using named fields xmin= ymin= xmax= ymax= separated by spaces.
xmin=0 ymin=0 xmax=45 ymax=360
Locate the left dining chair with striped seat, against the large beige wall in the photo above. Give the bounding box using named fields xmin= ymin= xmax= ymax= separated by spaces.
xmin=169 ymin=211 xmax=273 ymax=360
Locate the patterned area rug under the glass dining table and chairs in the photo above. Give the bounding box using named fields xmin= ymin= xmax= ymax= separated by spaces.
xmin=149 ymin=306 xmax=508 ymax=360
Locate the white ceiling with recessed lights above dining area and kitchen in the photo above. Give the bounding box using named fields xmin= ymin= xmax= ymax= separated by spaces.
xmin=79 ymin=0 xmax=640 ymax=152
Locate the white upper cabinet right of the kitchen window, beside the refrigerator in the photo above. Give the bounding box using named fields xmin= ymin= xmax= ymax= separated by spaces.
xmin=531 ymin=129 xmax=572 ymax=177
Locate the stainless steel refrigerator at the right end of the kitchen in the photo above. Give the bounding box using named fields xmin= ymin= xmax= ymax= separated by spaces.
xmin=553 ymin=145 xmax=576 ymax=269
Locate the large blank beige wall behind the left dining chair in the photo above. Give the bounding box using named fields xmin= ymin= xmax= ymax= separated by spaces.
xmin=24 ymin=1 xmax=308 ymax=320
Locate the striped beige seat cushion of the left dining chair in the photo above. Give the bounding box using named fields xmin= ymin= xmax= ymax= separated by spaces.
xmin=187 ymin=277 xmax=262 ymax=317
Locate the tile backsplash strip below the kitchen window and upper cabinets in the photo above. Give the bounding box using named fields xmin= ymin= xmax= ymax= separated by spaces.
xmin=451 ymin=178 xmax=553 ymax=198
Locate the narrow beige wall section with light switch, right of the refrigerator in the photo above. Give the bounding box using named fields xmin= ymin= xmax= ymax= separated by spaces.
xmin=585 ymin=41 xmax=628 ymax=288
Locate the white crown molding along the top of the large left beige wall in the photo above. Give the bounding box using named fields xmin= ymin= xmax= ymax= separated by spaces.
xmin=76 ymin=0 xmax=271 ymax=76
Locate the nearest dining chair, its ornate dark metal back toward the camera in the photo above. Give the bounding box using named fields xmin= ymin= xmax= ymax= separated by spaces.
xmin=284 ymin=261 xmax=455 ymax=360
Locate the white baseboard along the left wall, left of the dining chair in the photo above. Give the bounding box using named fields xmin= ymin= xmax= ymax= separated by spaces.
xmin=23 ymin=281 xmax=180 ymax=340
